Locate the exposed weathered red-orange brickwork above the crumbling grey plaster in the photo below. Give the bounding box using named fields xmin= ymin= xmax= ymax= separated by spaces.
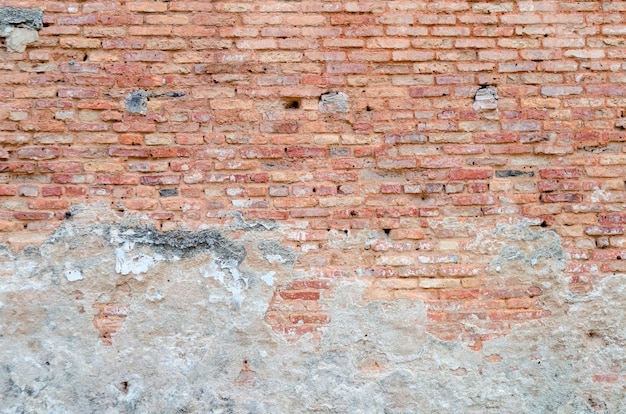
xmin=0 ymin=0 xmax=626 ymax=349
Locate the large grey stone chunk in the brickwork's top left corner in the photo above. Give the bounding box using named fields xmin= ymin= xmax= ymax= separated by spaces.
xmin=0 ymin=7 xmax=43 ymax=53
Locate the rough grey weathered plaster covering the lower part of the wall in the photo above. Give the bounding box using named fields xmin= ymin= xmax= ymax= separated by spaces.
xmin=0 ymin=206 xmax=626 ymax=413
